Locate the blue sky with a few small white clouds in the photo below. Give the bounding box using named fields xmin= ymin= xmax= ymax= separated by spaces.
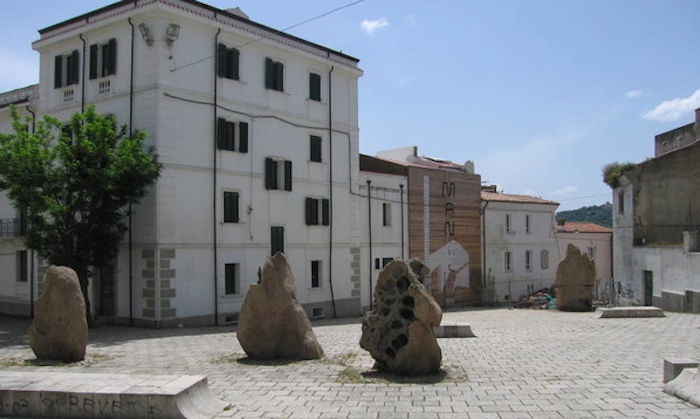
xmin=0 ymin=0 xmax=700 ymax=211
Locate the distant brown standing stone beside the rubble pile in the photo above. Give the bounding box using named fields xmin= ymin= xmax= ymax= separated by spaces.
xmin=554 ymin=244 xmax=596 ymax=311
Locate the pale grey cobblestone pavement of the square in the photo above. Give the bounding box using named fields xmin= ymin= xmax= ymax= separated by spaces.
xmin=0 ymin=309 xmax=700 ymax=419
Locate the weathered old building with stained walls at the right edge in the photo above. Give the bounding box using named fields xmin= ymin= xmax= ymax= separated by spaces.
xmin=613 ymin=109 xmax=700 ymax=313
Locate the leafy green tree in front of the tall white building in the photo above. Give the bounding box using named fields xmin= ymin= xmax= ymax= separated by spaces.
xmin=0 ymin=106 xmax=162 ymax=322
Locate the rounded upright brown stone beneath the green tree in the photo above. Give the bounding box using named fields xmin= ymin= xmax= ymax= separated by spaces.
xmin=29 ymin=266 xmax=88 ymax=362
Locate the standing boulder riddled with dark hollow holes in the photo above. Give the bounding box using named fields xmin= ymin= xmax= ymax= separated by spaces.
xmin=360 ymin=259 xmax=442 ymax=376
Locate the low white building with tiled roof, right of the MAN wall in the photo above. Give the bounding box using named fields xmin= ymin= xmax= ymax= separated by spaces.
xmin=481 ymin=188 xmax=564 ymax=303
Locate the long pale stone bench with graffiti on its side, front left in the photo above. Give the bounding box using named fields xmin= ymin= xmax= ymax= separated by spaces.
xmin=0 ymin=371 xmax=230 ymax=419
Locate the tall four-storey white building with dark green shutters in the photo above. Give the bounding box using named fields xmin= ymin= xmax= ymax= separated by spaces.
xmin=0 ymin=0 xmax=368 ymax=326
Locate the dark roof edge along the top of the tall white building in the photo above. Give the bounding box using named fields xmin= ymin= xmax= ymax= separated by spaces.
xmin=39 ymin=0 xmax=360 ymax=63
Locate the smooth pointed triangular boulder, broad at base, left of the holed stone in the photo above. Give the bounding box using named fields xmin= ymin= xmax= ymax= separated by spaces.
xmin=237 ymin=253 xmax=323 ymax=360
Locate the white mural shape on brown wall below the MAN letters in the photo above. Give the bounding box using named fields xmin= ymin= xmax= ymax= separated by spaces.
xmin=426 ymin=240 xmax=469 ymax=304
